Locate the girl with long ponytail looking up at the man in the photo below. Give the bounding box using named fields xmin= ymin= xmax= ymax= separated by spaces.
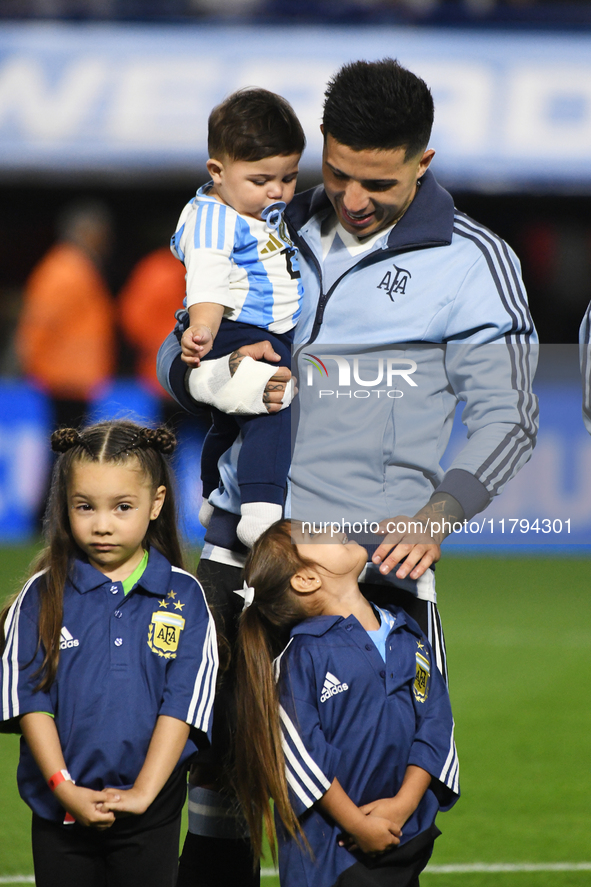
xmin=235 ymin=521 xmax=459 ymax=887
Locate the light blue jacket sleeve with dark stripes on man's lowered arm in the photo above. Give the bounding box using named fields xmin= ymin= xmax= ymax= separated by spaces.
xmin=446 ymin=211 xmax=538 ymax=518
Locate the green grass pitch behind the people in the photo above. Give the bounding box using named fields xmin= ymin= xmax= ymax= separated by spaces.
xmin=0 ymin=549 xmax=591 ymax=887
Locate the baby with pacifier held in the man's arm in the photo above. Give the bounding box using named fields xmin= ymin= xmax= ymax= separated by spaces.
xmin=171 ymin=89 xmax=305 ymax=547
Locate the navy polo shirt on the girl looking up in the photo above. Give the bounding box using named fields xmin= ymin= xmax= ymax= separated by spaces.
xmin=278 ymin=607 xmax=459 ymax=887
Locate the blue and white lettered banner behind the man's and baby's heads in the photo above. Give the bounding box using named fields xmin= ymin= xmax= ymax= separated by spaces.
xmin=0 ymin=23 xmax=591 ymax=190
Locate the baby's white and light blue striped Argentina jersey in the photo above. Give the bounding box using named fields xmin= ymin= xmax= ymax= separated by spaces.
xmin=171 ymin=185 xmax=303 ymax=333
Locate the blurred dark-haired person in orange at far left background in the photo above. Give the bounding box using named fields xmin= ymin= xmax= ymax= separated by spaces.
xmin=16 ymin=203 xmax=115 ymax=427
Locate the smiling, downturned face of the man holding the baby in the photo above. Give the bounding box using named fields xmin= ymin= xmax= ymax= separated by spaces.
xmin=322 ymin=134 xmax=435 ymax=237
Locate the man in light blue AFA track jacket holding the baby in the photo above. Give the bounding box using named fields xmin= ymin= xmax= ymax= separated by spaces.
xmin=159 ymin=59 xmax=537 ymax=883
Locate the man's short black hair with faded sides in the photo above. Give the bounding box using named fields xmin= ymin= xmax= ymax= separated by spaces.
xmin=323 ymin=59 xmax=433 ymax=160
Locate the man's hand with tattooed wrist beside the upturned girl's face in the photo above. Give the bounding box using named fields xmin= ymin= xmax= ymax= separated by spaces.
xmin=372 ymin=493 xmax=464 ymax=579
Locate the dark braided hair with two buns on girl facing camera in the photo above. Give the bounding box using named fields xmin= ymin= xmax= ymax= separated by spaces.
xmin=0 ymin=420 xmax=183 ymax=690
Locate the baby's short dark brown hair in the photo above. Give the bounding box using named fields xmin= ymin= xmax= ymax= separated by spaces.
xmin=207 ymin=89 xmax=306 ymax=160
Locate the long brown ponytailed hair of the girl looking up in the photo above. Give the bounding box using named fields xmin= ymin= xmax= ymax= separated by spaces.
xmin=235 ymin=521 xmax=311 ymax=859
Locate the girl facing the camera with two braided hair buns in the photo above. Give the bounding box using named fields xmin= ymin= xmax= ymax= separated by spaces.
xmin=0 ymin=421 xmax=217 ymax=887
